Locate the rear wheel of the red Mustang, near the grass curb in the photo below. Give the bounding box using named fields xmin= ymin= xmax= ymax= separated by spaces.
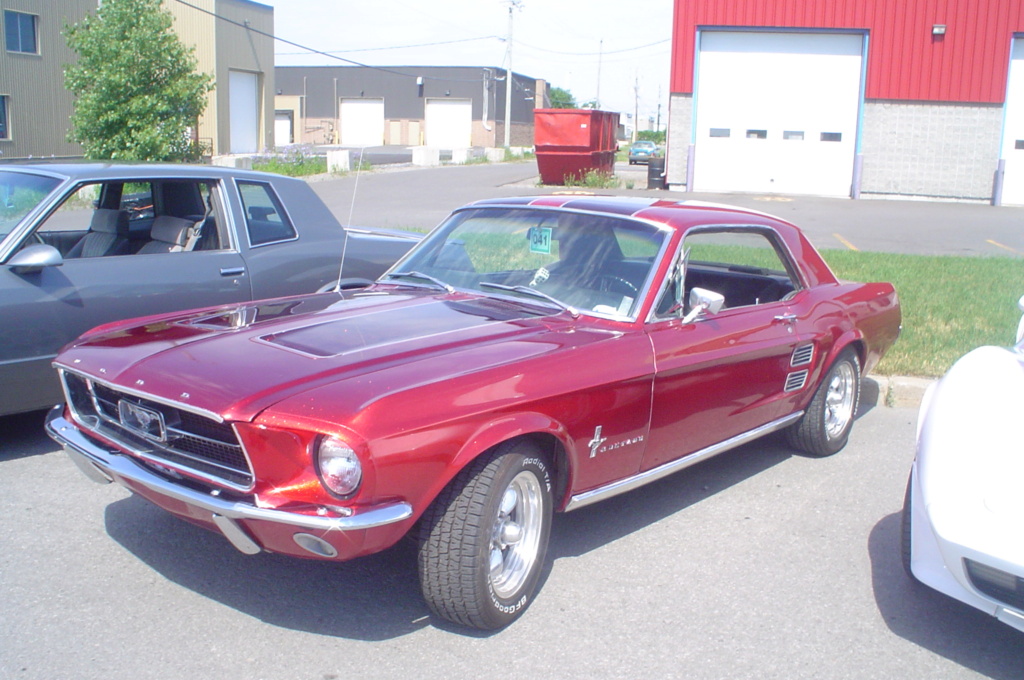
xmin=787 ymin=348 xmax=860 ymax=457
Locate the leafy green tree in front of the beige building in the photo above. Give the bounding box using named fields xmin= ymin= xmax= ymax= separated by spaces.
xmin=65 ymin=0 xmax=213 ymax=161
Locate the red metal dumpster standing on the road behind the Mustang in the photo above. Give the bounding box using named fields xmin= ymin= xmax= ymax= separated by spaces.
xmin=534 ymin=109 xmax=618 ymax=184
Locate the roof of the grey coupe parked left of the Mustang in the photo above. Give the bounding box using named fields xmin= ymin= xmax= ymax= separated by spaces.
xmin=0 ymin=161 xmax=289 ymax=181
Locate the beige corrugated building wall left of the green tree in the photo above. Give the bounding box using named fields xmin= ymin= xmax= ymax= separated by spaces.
xmin=0 ymin=0 xmax=96 ymax=159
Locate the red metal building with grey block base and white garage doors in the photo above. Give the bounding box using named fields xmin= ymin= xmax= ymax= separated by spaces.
xmin=669 ymin=0 xmax=1024 ymax=204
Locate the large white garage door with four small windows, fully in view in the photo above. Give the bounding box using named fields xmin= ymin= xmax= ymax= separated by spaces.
xmin=693 ymin=31 xmax=863 ymax=197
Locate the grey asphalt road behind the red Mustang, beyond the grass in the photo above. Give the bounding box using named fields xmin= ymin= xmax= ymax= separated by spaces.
xmin=312 ymin=161 xmax=1024 ymax=257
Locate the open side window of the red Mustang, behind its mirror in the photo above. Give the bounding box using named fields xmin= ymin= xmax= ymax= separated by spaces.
xmin=657 ymin=227 xmax=800 ymax=315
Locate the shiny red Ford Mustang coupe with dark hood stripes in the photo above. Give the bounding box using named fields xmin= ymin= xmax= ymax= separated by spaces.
xmin=47 ymin=197 xmax=900 ymax=629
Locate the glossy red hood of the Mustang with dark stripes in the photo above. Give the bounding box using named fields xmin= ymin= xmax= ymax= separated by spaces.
xmin=55 ymin=290 xmax=569 ymax=420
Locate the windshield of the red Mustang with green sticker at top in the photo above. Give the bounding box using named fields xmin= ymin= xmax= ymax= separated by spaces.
xmin=385 ymin=208 xmax=667 ymax=317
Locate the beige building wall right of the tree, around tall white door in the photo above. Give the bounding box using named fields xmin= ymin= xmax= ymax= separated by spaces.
xmin=164 ymin=0 xmax=274 ymax=155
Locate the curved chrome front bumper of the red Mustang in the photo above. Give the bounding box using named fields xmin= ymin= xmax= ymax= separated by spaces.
xmin=46 ymin=405 xmax=413 ymax=555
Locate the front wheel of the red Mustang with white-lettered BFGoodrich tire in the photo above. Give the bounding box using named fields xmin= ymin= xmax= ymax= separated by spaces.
xmin=418 ymin=441 xmax=552 ymax=630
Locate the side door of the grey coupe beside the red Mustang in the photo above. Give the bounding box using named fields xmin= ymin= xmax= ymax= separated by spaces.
xmin=0 ymin=175 xmax=251 ymax=413
